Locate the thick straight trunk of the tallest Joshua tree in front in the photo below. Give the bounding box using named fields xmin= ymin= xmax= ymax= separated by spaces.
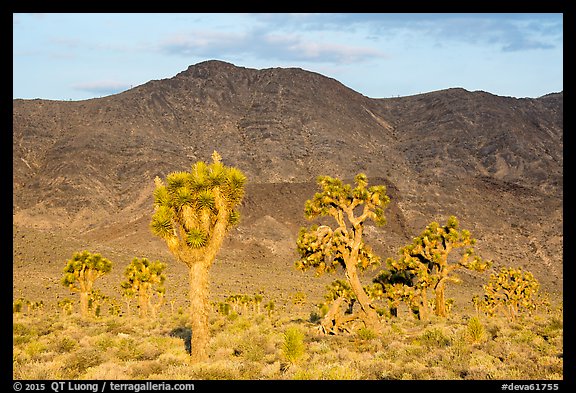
xmin=188 ymin=261 xmax=210 ymax=363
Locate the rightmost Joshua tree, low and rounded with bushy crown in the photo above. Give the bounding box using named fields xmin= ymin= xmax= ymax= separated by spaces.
xmin=480 ymin=267 xmax=540 ymax=321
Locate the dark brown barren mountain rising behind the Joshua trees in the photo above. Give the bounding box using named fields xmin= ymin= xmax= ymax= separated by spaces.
xmin=13 ymin=61 xmax=563 ymax=306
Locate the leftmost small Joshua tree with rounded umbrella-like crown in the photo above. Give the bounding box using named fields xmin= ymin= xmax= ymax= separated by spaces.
xmin=62 ymin=251 xmax=112 ymax=317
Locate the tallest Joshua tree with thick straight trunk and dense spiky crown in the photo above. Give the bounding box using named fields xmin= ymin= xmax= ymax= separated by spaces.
xmin=150 ymin=152 xmax=246 ymax=362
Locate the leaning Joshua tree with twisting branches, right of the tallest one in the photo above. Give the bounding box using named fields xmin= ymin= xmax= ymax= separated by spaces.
xmin=296 ymin=174 xmax=390 ymax=331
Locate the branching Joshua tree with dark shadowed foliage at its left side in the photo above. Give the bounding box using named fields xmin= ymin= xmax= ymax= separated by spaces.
xmin=401 ymin=216 xmax=492 ymax=317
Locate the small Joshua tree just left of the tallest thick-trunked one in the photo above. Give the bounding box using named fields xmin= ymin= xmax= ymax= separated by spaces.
xmin=120 ymin=258 xmax=166 ymax=317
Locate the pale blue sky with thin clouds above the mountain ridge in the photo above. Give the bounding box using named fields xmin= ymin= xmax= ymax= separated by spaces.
xmin=13 ymin=13 xmax=564 ymax=100
